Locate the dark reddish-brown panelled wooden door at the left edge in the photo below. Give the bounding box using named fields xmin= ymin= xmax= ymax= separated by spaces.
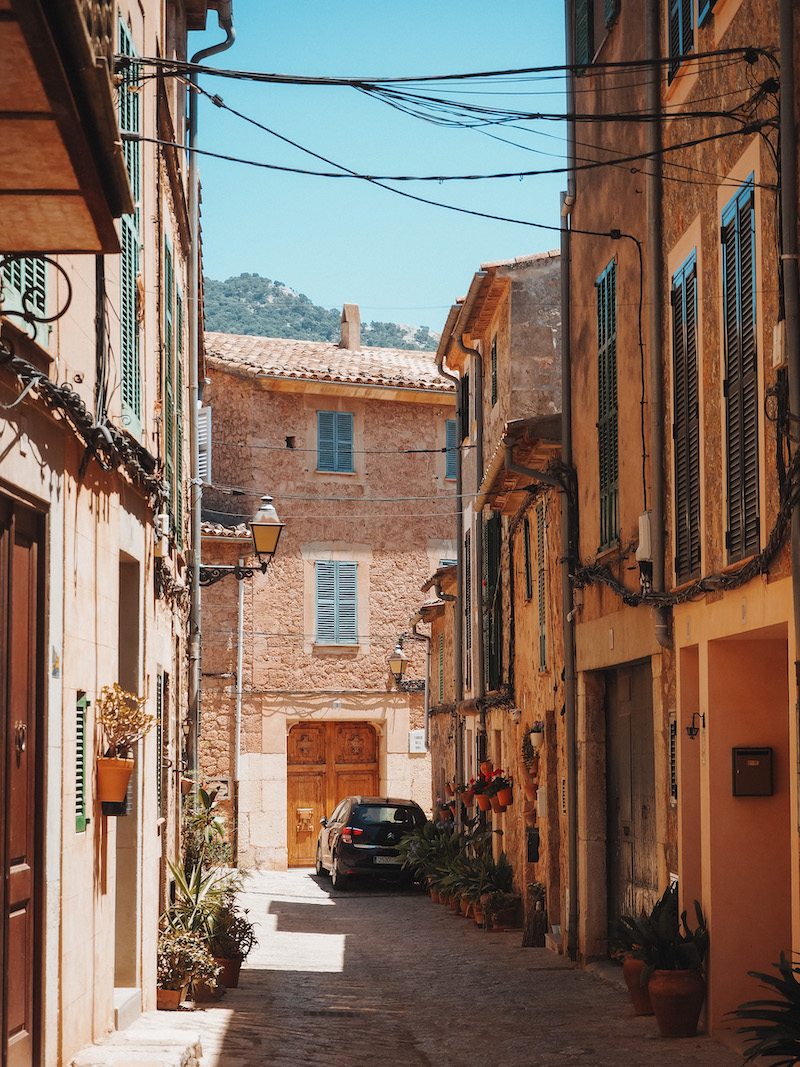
xmin=0 ymin=497 xmax=43 ymax=1067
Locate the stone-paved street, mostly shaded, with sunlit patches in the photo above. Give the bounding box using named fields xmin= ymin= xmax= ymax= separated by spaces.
xmin=76 ymin=871 xmax=741 ymax=1067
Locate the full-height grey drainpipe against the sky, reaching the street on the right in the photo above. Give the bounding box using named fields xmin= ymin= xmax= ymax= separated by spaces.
xmin=561 ymin=2 xmax=578 ymax=959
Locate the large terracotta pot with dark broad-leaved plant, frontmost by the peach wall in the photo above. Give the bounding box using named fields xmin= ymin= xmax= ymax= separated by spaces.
xmin=620 ymin=883 xmax=708 ymax=1037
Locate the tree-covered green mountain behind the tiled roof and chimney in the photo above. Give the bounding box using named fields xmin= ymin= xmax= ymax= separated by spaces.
xmin=203 ymin=274 xmax=438 ymax=352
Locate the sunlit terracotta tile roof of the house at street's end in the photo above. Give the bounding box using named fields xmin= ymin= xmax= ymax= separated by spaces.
xmin=205 ymin=333 xmax=454 ymax=393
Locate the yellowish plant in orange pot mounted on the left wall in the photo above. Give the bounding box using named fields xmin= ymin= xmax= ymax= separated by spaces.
xmin=95 ymin=682 xmax=156 ymax=803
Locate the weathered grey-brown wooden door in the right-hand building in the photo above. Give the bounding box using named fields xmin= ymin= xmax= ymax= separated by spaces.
xmin=606 ymin=664 xmax=658 ymax=924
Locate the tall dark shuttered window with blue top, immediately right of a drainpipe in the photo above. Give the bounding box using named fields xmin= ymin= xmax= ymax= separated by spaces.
xmin=671 ymin=253 xmax=700 ymax=582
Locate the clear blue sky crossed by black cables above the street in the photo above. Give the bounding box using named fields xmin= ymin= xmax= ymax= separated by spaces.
xmin=190 ymin=0 xmax=565 ymax=332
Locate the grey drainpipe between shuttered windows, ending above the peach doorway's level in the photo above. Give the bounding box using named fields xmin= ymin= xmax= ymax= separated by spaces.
xmin=644 ymin=0 xmax=670 ymax=649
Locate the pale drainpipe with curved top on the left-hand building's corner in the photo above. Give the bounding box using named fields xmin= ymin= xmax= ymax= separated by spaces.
xmin=187 ymin=6 xmax=235 ymax=774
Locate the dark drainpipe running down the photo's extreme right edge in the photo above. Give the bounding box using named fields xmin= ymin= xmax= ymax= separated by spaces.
xmin=779 ymin=0 xmax=800 ymax=793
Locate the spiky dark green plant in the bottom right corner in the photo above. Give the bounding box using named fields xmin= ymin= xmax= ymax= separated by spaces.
xmin=727 ymin=952 xmax=800 ymax=1067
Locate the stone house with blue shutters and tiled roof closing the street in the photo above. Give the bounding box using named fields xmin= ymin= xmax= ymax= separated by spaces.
xmin=201 ymin=305 xmax=454 ymax=869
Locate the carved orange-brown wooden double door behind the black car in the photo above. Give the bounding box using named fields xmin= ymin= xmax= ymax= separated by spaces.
xmin=287 ymin=722 xmax=380 ymax=866
